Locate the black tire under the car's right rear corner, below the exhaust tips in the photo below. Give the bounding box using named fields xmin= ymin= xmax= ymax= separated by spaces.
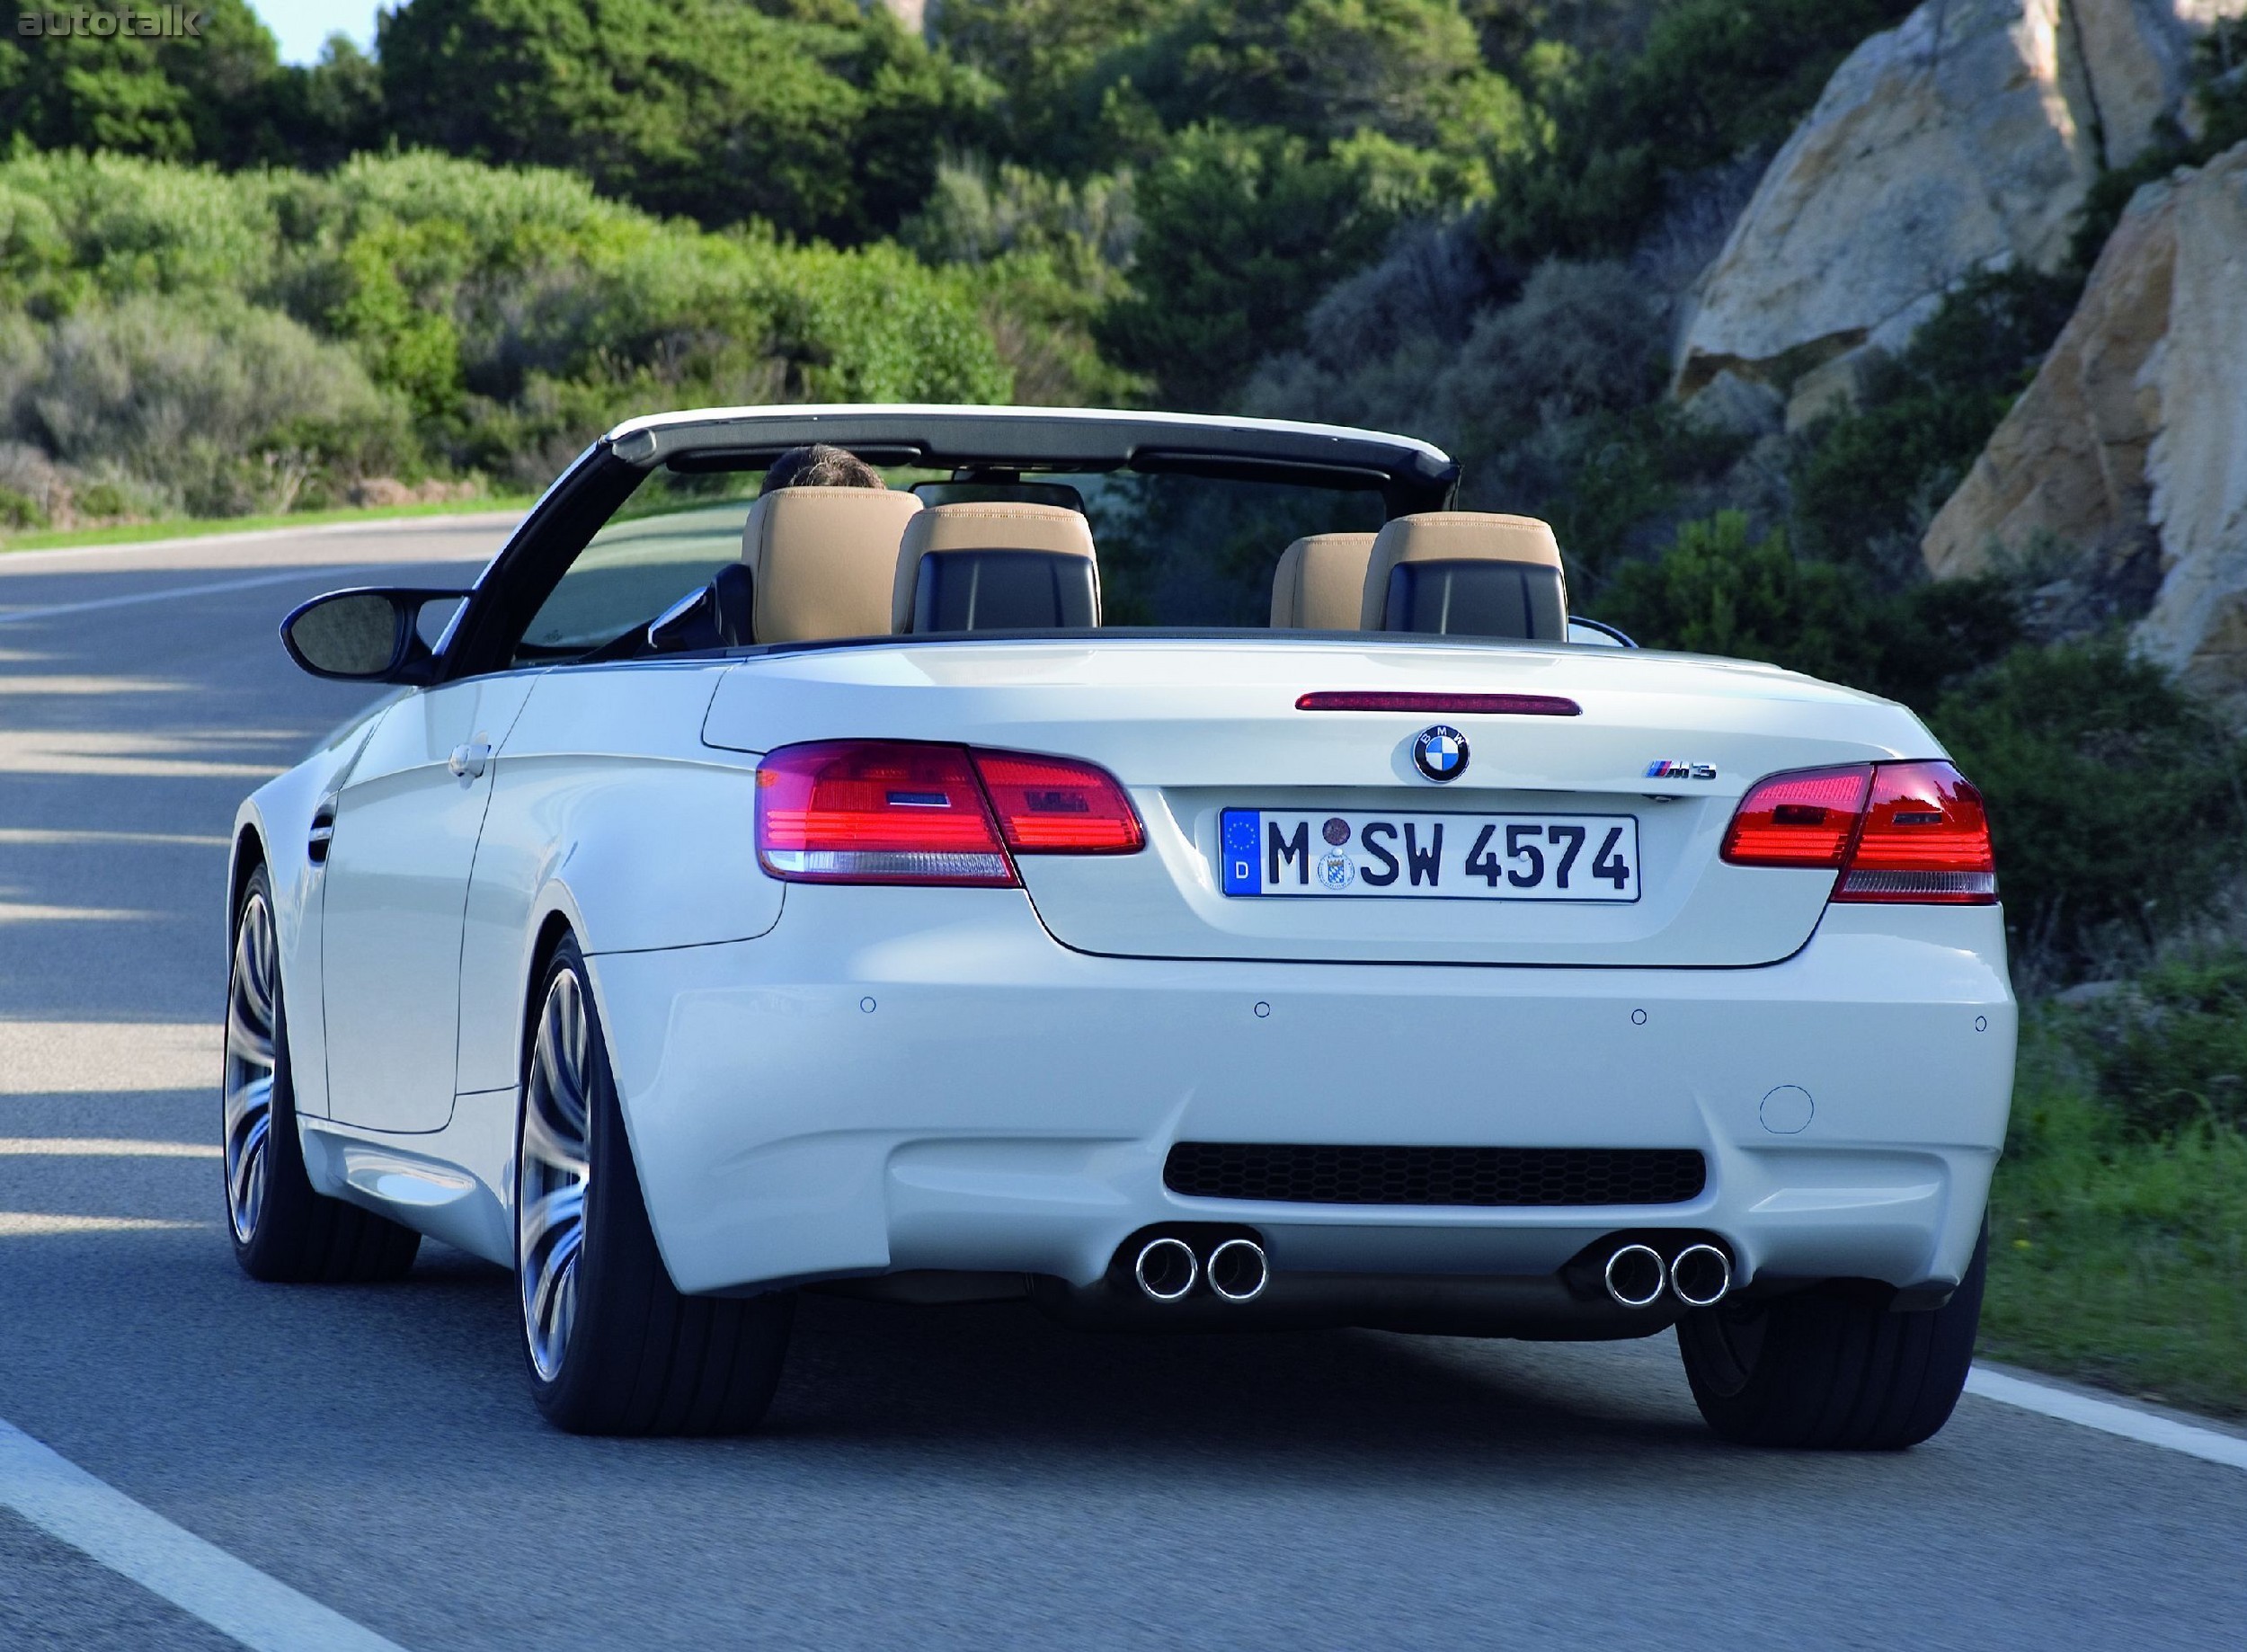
xmin=1679 ymin=1221 xmax=1989 ymax=1452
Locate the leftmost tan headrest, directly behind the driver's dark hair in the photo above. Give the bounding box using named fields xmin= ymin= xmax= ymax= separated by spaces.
xmin=742 ymin=488 xmax=921 ymax=643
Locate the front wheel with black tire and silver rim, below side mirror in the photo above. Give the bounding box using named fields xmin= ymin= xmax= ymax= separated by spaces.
xmin=218 ymin=866 xmax=421 ymax=1285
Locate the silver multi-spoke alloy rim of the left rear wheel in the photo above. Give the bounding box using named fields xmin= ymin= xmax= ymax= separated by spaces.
xmin=515 ymin=969 xmax=591 ymax=1382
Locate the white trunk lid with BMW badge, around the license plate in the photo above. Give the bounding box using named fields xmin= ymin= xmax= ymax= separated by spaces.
xmin=704 ymin=636 xmax=1944 ymax=966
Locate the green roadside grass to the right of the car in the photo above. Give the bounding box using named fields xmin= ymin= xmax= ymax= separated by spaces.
xmin=1982 ymin=1018 xmax=2247 ymax=1418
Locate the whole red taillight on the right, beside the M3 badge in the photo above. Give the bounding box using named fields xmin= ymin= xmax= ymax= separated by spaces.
xmin=1724 ymin=762 xmax=1998 ymax=906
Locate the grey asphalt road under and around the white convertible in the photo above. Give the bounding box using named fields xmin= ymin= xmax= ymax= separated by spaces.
xmin=0 ymin=524 xmax=2247 ymax=1652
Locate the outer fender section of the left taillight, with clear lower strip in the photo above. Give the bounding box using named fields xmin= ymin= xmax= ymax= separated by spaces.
xmin=758 ymin=740 xmax=1016 ymax=885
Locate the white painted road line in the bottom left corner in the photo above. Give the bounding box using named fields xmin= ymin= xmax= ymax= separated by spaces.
xmin=0 ymin=1420 xmax=400 ymax=1652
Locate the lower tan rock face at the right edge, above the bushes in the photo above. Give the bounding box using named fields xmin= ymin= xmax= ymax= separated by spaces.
xmin=1922 ymin=144 xmax=2247 ymax=715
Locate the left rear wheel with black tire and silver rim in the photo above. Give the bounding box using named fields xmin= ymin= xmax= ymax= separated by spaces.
xmin=515 ymin=937 xmax=795 ymax=1434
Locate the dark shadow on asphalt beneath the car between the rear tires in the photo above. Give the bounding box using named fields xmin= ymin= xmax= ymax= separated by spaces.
xmin=767 ymin=1297 xmax=1706 ymax=1479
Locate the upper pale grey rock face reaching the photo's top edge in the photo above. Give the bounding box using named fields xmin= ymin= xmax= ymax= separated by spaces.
xmin=1676 ymin=0 xmax=2247 ymax=395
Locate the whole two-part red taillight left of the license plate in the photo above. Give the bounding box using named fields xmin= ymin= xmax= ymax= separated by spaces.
xmin=758 ymin=740 xmax=1146 ymax=888
